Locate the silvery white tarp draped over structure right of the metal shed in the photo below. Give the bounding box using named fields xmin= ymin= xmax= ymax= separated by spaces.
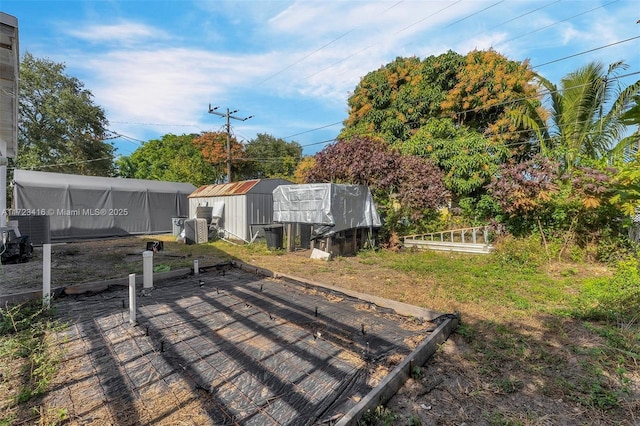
xmin=273 ymin=183 xmax=381 ymax=237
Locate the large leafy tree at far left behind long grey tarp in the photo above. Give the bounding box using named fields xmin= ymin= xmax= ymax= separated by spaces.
xmin=15 ymin=53 xmax=114 ymax=176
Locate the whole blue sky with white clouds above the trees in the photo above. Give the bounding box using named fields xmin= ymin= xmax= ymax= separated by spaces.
xmin=0 ymin=0 xmax=640 ymax=155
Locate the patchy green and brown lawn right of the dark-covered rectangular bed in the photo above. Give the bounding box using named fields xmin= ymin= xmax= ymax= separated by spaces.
xmin=215 ymin=242 xmax=640 ymax=425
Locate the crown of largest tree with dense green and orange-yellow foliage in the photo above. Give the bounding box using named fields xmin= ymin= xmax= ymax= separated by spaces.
xmin=341 ymin=50 xmax=542 ymax=158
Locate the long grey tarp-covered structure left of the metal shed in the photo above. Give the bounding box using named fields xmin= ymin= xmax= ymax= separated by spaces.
xmin=10 ymin=170 xmax=195 ymax=241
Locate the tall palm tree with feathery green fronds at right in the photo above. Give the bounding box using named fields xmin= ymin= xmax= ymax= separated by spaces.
xmin=514 ymin=62 xmax=640 ymax=172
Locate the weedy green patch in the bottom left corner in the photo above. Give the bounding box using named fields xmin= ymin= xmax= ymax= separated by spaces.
xmin=0 ymin=301 xmax=66 ymax=425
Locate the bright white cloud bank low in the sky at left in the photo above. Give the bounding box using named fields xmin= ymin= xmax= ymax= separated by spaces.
xmin=74 ymin=48 xmax=268 ymax=123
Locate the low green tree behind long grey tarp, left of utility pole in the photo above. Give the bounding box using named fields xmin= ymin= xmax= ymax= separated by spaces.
xmin=116 ymin=134 xmax=219 ymax=186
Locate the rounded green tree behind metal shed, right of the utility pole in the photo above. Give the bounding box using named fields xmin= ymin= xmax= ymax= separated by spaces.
xmin=244 ymin=133 xmax=302 ymax=179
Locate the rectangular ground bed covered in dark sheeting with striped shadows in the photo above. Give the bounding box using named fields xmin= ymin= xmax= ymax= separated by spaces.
xmin=33 ymin=264 xmax=457 ymax=425
